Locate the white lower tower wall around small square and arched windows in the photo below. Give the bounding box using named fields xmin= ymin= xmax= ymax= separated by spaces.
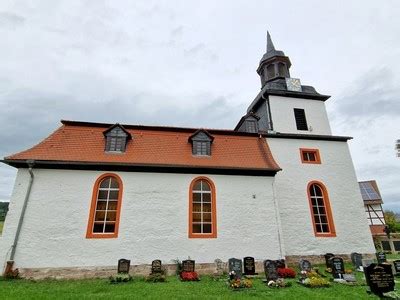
xmin=267 ymin=138 xmax=375 ymax=255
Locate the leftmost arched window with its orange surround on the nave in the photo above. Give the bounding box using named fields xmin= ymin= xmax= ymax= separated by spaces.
xmin=86 ymin=174 xmax=122 ymax=238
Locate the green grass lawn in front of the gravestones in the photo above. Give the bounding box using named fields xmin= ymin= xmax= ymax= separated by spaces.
xmin=0 ymin=273 xmax=388 ymax=300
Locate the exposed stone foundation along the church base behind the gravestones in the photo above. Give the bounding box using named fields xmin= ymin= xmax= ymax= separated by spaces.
xmin=19 ymin=254 xmax=375 ymax=280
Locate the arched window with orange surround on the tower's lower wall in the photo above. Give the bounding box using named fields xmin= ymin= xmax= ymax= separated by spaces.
xmin=308 ymin=181 xmax=336 ymax=237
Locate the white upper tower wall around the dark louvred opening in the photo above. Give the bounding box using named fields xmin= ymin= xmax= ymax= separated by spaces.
xmin=269 ymin=95 xmax=332 ymax=135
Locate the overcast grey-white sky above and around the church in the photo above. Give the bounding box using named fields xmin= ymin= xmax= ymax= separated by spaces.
xmin=0 ymin=0 xmax=400 ymax=212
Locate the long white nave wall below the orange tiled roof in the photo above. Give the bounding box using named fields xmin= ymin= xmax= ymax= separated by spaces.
xmin=0 ymin=169 xmax=280 ymax=268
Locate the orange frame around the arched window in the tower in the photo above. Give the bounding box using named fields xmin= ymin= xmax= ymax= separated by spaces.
xmin=307 ymin=180 xmax=336 ymax=237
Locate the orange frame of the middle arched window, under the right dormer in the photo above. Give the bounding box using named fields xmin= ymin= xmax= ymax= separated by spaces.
xmin=189 ymin=176 xmax=217 ymax=239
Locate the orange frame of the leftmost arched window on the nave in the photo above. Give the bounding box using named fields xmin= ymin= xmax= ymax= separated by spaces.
xmin=86 ymin=173 xmax=123 ymax=239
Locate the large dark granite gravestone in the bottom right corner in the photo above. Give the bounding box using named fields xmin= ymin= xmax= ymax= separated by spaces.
xmin=364 ymin=264 xmax=394 ymax=297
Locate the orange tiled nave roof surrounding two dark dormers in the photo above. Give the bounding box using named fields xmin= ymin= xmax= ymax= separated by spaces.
xmin=4 ymin=121 xmax=280 ymax=175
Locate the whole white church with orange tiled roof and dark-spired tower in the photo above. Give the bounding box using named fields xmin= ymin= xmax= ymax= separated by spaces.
xmin=0 ymin=34 xmax=375 ymax=278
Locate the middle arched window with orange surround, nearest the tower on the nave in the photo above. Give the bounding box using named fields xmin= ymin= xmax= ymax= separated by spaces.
xmin=189 ymin=177 xmax=217 ymax=238
